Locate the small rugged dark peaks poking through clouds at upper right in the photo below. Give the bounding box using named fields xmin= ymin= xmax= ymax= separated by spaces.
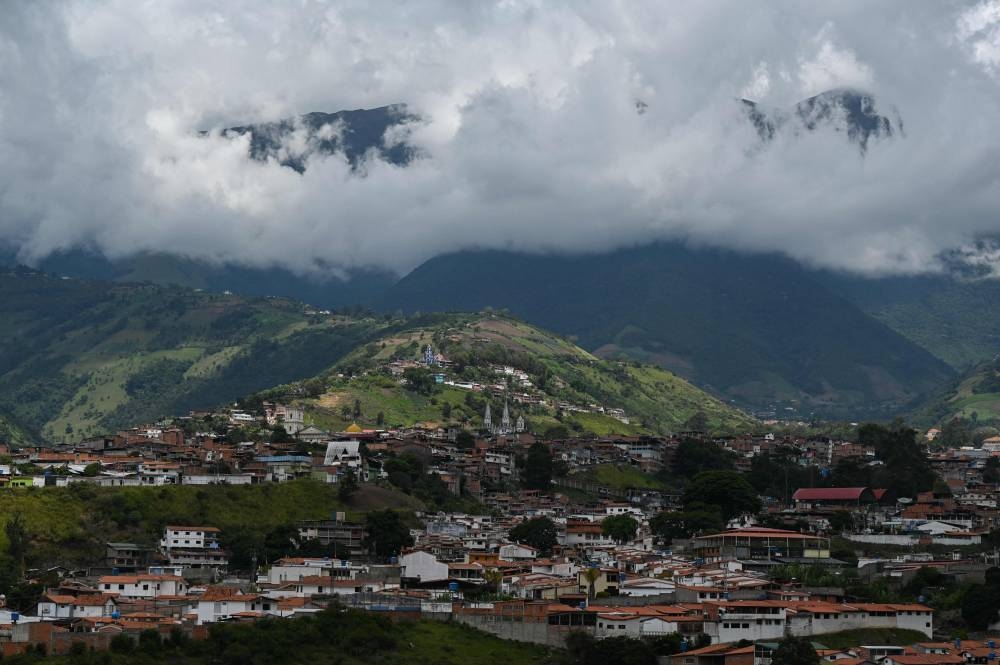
xmin=741 ymin=88 xmax=903 ymax=153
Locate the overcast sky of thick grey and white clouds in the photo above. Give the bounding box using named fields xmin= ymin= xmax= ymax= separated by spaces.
xmin=0 ymin=0 xmax=1000 ymax=273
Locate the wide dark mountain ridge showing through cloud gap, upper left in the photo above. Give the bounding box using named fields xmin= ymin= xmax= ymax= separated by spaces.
xmin=213 ymin=104 xmax=419 ymax=173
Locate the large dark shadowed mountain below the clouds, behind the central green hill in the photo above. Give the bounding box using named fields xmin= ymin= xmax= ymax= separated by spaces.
xmin=380 ymin=244 xmax=955 ymax=419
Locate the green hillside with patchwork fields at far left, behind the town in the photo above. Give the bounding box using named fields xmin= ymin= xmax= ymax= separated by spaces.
xmin=0 ymin=270 xmax=385 ymax=441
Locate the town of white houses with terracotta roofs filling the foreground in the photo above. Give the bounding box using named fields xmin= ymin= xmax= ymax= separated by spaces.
xmin=0 ymin=386 xmax=1000 ymax=665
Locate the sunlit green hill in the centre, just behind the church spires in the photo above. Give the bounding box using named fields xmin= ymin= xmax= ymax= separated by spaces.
xmin=267 ymin=313 xmax=755 ymax=435
